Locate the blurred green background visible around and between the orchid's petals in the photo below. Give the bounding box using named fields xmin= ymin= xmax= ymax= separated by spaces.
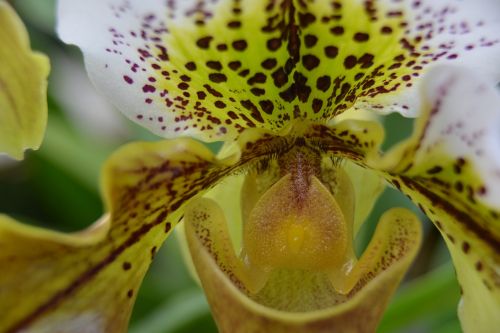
xmin=0 ymin=0 xmax=460 ymax=333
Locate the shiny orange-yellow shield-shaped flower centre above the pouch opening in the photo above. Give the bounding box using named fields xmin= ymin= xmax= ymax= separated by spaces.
xmin=243 ymin=147 xmax=352 ymax=272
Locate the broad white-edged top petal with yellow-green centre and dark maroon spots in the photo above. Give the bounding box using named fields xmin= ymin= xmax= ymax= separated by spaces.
xmin=59 ymin=0 xmax=500 ymax=141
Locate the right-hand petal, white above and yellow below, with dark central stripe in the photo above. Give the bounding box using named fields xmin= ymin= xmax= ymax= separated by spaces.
xmin=374 ymin=67 xmax=500 ymax=332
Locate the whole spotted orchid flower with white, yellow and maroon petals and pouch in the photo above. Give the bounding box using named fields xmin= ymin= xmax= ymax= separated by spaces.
xmin=0 ymin=0 xmax=500 ymax=332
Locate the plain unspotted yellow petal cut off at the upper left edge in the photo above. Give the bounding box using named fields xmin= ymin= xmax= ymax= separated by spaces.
xmin=0 ymin=1 xmax=49 ymax=160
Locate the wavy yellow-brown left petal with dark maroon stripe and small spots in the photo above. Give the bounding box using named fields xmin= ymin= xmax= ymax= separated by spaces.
xmin=0 ymin=139 xmax=237 ymax=332
